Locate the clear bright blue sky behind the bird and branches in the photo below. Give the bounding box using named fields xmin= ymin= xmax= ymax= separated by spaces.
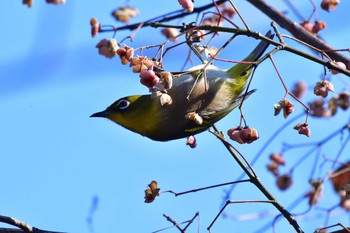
xmin=0 ymin=0 xmax=350 ymax=233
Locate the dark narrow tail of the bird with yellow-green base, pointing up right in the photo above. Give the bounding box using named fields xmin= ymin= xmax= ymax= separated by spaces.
xmin=227 ymin=31 xmax=274 ymax=78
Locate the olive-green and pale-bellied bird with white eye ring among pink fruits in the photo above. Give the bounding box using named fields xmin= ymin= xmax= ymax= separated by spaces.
xmin=90 ymin=31 xmax=274 ymax=141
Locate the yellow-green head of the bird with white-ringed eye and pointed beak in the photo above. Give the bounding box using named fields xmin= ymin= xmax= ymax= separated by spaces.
xmin=90 ymin=95 xmax=159 ymax=136
